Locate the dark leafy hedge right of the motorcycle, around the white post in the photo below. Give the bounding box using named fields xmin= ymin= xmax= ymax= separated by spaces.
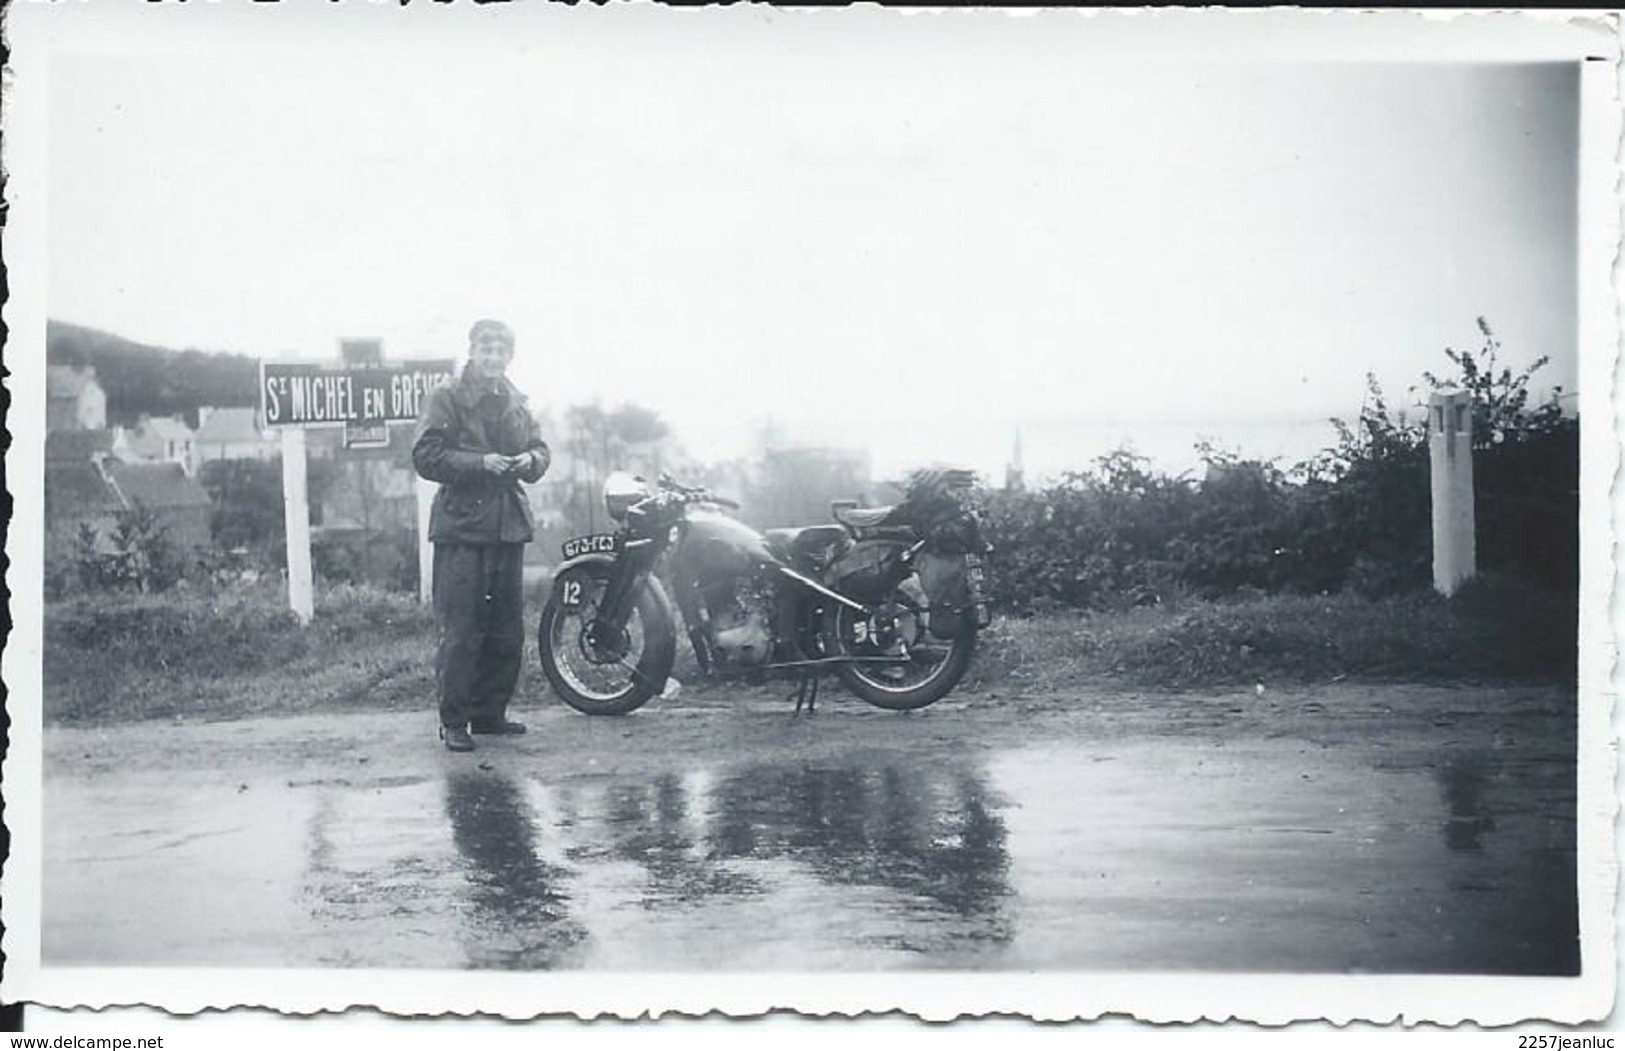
xmin=985 ymin=318 xmax=1580 ymax=614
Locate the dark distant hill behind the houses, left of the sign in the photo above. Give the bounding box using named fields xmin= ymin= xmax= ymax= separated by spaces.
xmin=46 ymin=322 xmax=260 ymax=426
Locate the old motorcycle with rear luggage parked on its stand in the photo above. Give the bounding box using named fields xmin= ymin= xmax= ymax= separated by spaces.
xmin=536 ymin=469 xmax=991 ymax=715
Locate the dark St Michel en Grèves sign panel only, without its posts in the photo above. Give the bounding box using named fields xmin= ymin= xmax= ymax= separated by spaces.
xmin=260 ymin=359 xmax=457 ymax=427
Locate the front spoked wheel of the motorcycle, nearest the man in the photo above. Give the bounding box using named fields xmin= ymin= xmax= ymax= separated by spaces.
xmin=536 ymin=565 xmax=678 ymax=715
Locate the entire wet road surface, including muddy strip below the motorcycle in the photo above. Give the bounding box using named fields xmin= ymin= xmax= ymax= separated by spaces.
xmin=42 ymin=687 xmax=1578 ymax=975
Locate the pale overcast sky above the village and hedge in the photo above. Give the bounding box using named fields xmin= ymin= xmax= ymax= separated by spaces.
xmin=49 ymin=8 xmax=1578 ymax=484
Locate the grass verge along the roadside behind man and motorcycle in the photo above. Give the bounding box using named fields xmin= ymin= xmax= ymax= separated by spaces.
xmin=44 ymin=578 xmax=1576 ymax=723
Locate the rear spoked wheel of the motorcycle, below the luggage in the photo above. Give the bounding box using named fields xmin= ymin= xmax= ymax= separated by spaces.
xmin=830 ymin=578 xmax=977 ymax=711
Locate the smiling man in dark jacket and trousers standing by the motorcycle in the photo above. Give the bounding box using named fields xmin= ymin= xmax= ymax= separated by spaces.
xmin=411 ymin=318 xmax=553 ymax=752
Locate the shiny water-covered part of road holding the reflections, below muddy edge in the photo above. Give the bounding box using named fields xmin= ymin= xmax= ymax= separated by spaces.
xmin=41 ymin=727 xmax=1580 ymax=975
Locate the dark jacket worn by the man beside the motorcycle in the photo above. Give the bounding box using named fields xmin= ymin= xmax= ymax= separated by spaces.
xmin=411 ymin=365 xmax=553 ymax=544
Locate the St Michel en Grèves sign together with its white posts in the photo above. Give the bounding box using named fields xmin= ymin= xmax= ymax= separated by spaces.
xmin=260 ymin=359 xmax=457 ymax=622
